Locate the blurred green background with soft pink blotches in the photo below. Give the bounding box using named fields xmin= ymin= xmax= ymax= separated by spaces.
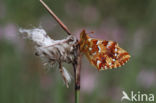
xmin=0 ymin=0 xmax=156 ymax=103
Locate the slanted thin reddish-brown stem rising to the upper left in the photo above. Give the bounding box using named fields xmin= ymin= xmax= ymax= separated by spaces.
xmin=40 ymin=0 xmax=71 ymax=35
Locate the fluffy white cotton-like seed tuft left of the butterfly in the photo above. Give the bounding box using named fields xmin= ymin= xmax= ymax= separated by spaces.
xmin=19 ymin=28 xmax=78 ymax=87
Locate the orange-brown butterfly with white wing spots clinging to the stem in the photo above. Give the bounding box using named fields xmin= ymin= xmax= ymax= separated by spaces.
xmin=79 ymin=30 xmax=131 ymax=70
